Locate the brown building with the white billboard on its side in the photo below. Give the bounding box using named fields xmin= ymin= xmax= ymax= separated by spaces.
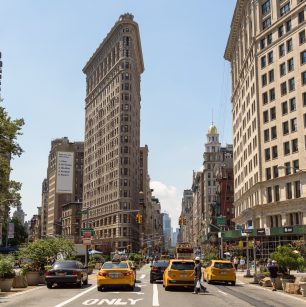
xmin=42 ymin=137 xmax=84 ymax=236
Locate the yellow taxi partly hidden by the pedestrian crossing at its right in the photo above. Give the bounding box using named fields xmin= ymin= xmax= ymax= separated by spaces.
xmin=163 ymin=259 xmax=194 ymax=291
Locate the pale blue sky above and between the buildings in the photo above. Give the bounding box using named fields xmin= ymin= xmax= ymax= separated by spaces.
xmin=0 ymin=0 xmax=236 ymax=229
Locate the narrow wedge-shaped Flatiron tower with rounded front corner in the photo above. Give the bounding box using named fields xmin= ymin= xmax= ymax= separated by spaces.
xmin=83 ymin=14 xmax=144 ymax=251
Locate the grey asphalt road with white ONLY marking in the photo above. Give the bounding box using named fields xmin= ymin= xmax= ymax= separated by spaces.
xmin=0 ymin=266 xmax=306 ymax=307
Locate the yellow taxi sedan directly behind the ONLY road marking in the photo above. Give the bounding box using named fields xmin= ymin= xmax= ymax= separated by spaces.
xmin=97 ymin=260 xmax=136 ymax=291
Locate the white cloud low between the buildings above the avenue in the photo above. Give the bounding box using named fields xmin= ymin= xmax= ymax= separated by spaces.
xmin=150 ymin=181 xmax=183 ymax=230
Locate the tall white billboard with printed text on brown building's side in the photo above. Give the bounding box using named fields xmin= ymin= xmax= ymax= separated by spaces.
xmin=56 ymin=151 xmax=74 ymax=194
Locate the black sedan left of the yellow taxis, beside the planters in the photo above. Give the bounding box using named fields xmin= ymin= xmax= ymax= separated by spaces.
xmin=45 ymin=260 xmax=88 ymax=289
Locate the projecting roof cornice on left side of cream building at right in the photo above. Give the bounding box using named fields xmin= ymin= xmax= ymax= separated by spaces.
xmin=224 ymin=0 xmax=247 ymax=62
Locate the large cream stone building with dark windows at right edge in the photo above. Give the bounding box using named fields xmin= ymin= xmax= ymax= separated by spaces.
xmin=224 ymin=0 xmax=306 ymax=233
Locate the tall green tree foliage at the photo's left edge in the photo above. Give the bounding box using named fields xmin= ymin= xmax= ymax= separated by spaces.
xmin=0 ymin=101 xmax=24 ymax=207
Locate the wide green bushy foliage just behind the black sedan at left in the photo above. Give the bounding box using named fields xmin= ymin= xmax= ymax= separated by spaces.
xmin=18 ymin=237 xmax=75 ymax=267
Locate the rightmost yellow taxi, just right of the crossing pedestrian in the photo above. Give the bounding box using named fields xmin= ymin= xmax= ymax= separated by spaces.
xmin=203 ymin=260 xmax=236 ymax=286
